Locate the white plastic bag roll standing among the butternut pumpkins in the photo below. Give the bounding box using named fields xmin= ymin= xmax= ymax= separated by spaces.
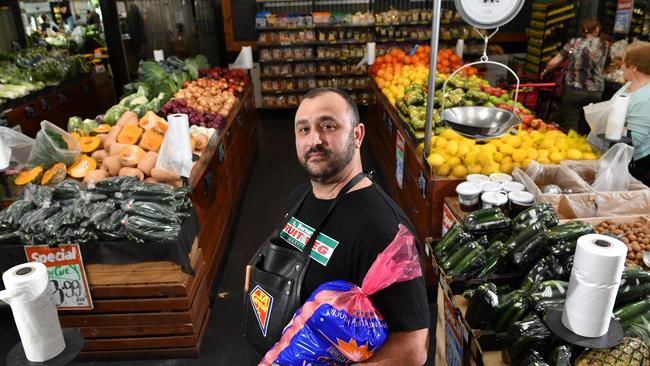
xmin=156 ymin=114 xmax=192 ymax=178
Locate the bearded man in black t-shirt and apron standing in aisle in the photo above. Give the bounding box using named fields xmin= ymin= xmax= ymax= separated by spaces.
xmin=245 ymin=88 xmax=430 ymax=365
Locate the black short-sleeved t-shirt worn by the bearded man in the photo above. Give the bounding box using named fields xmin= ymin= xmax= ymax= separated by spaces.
xmin=280 ymin=185 xmax=429 ymax=331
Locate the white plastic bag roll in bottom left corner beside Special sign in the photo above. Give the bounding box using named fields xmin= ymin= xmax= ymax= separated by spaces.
xmin=0 ymin=262 xmax=65 ymax=362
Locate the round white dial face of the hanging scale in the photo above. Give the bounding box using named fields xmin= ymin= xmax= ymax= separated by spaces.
xmin=454 ymin=0 xmax=524 ymax=29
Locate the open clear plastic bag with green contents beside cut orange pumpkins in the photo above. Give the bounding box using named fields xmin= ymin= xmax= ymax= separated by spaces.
xmin=27 ymin=121 xmax=81 ymax=169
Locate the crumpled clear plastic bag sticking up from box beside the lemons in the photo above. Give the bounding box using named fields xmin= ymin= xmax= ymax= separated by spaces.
xmin=591 ymin=143 xmax=634 ymax=192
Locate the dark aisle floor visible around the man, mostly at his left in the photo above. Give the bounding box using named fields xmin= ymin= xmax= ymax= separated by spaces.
xmin=0 ymin=106 xmax=416 ymax=366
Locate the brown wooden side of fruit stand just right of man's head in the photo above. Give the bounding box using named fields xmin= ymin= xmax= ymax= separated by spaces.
xmin=366 ymin=80 xmax=463 ymax=239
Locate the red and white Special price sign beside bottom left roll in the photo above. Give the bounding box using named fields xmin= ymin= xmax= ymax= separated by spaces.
xmin=25 ymin=244 xmax=93 ymax=310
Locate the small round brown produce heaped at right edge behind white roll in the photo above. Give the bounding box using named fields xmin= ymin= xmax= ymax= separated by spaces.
xmin=595 ymin=220 xmax=650 ymax=267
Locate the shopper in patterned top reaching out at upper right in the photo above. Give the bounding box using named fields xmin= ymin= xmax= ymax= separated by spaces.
xmin=542 ymin=17 xmax=609 ymax=133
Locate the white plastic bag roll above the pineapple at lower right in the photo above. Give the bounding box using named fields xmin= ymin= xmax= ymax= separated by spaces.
xmin=562 ymin=234 xmax=627 ymax=338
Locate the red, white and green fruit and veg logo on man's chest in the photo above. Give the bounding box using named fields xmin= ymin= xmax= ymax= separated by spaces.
xmin=280 ymin=217 xmax=339 ymax=266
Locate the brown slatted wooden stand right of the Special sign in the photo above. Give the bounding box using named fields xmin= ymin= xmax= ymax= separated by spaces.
xmin=59 ymin=238 xmax=210 ymax=359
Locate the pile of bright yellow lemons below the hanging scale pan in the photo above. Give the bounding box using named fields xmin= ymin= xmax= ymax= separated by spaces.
xmin=418 ymin=129 xmax=597 ymax=179
